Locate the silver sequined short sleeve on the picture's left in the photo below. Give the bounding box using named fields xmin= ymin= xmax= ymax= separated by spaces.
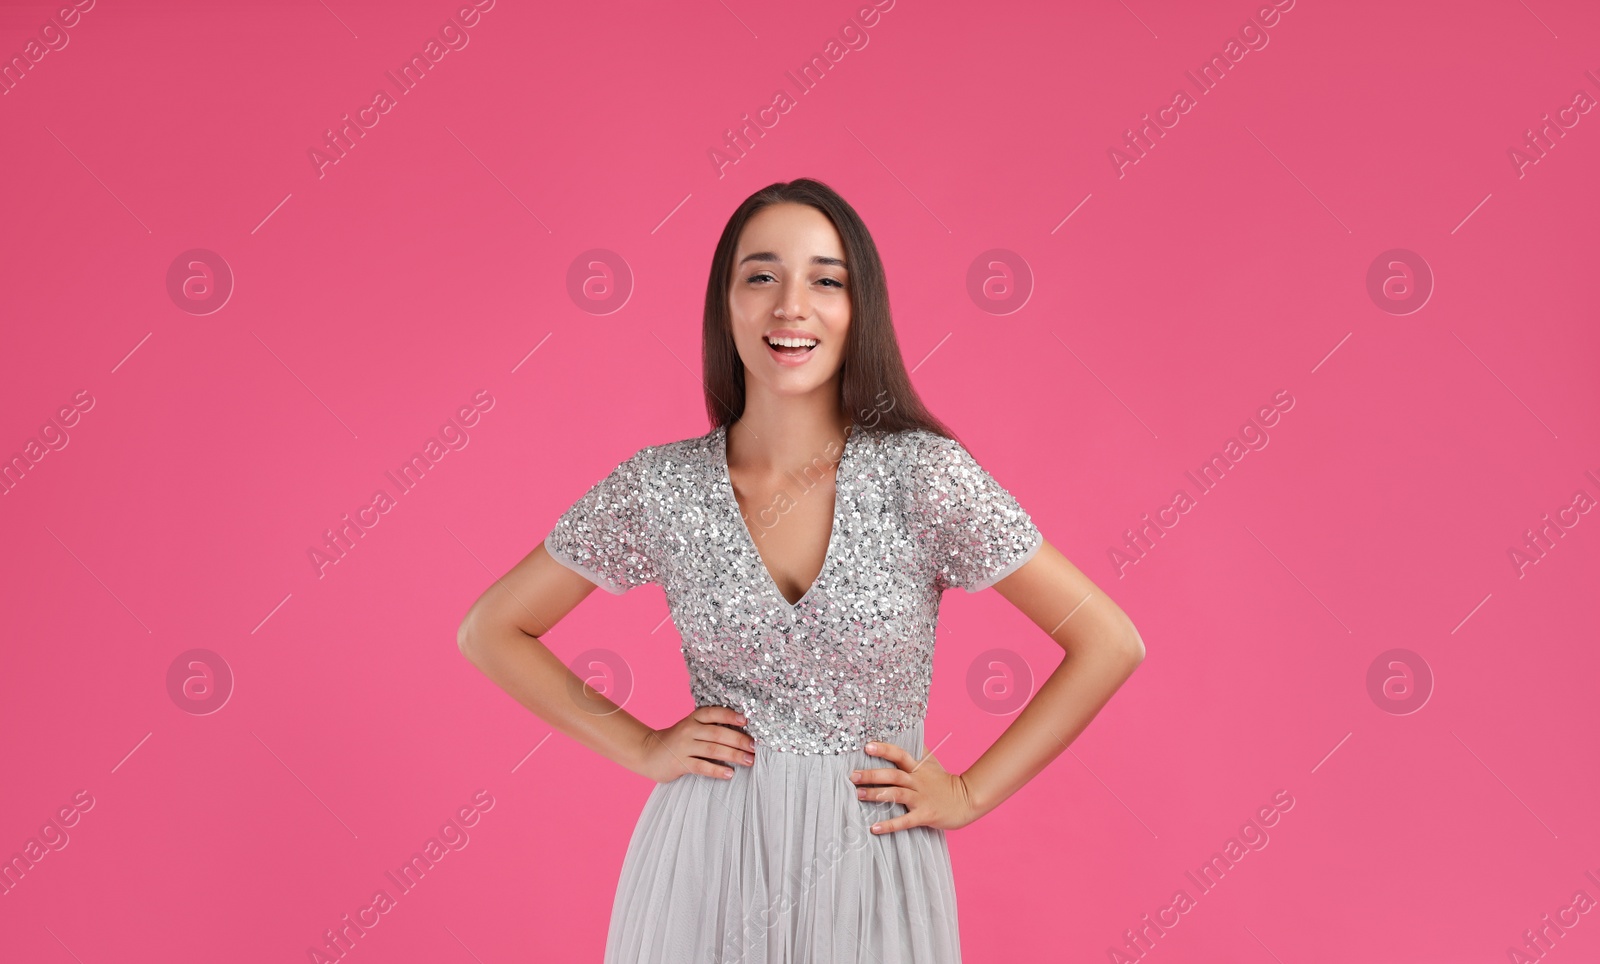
xmin=544 ymin=448 xmax=661 ymax=596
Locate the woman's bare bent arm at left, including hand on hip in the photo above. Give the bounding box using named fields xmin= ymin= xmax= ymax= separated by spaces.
xmin=456 ymin=543 xmax=754 ymax=781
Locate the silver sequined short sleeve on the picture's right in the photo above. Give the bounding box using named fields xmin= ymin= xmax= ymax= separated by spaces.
xmin=906 ymin=432 xmax=1045 ymax=592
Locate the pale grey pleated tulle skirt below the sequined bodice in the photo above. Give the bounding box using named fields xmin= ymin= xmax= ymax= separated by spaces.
xmin=605 ymin=724 xmax=962 ymax=964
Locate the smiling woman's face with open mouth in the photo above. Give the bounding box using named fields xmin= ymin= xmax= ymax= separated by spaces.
xmin=728 ymin=203 xmax=850 ymax=396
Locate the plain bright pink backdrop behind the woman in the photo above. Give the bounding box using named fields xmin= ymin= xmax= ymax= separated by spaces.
xmin=0 ymin=0 xmax=1600 ymax=964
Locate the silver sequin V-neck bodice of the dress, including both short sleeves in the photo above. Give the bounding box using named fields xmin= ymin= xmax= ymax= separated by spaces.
xmin=544 ymin=426 xmax=1043 ymax=754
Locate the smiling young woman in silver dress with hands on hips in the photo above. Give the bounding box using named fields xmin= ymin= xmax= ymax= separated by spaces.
xmin=459 ymin=179 xmax=1144 ymax=964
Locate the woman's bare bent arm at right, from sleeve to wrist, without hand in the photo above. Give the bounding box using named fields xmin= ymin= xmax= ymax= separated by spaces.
xmin=962 ymin=541 xmax=1144 ymax=817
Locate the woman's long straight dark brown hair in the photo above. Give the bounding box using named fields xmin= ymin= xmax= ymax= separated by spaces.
xmin=701 ymin=178 xmax=955 ymax=439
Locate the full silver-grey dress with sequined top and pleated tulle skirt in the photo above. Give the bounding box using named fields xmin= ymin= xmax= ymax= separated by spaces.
xmin=544 ymin=426 xmax=1043 ymax=964
